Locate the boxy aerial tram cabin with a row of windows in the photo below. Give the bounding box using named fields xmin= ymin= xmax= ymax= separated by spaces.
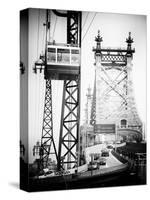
xmin=45 ymin=43 xmax=80 ymax=80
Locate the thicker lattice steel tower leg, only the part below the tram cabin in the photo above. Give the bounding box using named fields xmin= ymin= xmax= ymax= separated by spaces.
xmin=58 ymin=80 xmax=80 ymax=169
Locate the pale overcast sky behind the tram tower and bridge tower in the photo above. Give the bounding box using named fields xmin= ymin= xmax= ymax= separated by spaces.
xmin=29 ymin=9 xmax=146 ymax=162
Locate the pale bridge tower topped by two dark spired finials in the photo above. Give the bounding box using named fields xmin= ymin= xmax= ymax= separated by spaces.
xmin=91 ymin=31 xmax=142 ymax=140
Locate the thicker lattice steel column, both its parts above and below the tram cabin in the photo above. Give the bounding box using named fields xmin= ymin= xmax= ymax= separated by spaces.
xmin=58 ymin=11 xmax=81 ymax=170
